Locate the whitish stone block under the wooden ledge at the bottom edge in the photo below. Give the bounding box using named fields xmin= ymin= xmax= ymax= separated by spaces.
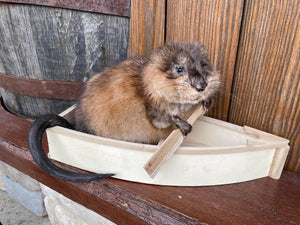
xmin=41 ymin=184 xmax=115 ymax=225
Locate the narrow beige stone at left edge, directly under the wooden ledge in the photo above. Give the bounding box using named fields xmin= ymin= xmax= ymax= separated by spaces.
xmin=0 ymin=161 xmax=41 ymax=191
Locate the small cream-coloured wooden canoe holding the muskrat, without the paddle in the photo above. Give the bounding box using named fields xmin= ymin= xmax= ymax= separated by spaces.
xmin=47 ymin=106 xmax=289 ymax=186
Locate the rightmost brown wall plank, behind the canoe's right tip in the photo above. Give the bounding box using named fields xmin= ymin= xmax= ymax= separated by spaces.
xmin=229 ymin=0 xmax=300 ymax=172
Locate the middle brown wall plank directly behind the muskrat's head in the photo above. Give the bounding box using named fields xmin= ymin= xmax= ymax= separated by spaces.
xmin=166 ymin=0 xmax=244 ymax=120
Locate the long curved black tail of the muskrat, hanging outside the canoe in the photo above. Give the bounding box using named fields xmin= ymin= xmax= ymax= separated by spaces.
xmin=28 ymin=114 xmax=114 ymax=182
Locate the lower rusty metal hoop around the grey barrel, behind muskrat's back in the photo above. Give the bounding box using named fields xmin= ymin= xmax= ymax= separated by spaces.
xmin=0 ymin=73 xmax=84 ymax=100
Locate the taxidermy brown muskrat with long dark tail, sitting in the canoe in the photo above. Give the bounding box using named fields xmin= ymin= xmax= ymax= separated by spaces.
xmin=28 ymin=43 xmax=220 ymax=182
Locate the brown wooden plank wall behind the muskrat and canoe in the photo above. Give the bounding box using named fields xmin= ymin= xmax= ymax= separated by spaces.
xmin=129 ymin=0 xmax=300 ymax=172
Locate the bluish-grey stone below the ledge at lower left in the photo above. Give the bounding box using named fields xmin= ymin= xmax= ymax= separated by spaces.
xmin=2 ymin=175 xmax=47 ymax=216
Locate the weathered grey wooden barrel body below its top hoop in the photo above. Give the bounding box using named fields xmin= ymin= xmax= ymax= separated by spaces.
xmin=0 ymin=4 xmax=129 ymax=117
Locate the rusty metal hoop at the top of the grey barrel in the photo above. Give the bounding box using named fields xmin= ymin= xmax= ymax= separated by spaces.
xmin=0 ymin=0 xmax=130 ymax=17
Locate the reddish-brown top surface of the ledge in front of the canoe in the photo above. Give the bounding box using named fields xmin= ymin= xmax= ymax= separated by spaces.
xmin=110 ymin=171 xmax=300 ymax=225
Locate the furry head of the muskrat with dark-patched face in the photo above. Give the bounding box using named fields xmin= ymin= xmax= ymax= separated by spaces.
xmin=144 ymin=43 xmax=220 ymax=105
